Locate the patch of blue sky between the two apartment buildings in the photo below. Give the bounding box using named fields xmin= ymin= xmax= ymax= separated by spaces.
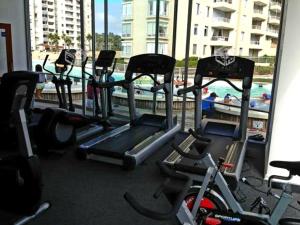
xmin=95 ymin=0 xmax=122 ymax=35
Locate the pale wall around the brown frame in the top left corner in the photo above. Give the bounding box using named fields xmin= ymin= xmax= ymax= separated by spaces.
xmin=0 ymin=0 xmax=27 ymax=70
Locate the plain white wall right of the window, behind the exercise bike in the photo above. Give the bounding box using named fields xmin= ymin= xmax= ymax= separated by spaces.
xmin=267 ymin=0 xmax=300 ymax=185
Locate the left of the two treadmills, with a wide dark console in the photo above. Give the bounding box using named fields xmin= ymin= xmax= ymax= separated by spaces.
xmin=78 ymin=54 xmax=180 ymax=169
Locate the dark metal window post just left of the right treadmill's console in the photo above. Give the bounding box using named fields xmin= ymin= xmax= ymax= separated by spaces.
xmin=181 ymin=0 xmax=193 ymax=130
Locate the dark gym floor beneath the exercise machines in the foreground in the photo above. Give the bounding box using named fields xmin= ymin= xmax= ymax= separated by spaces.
xmin=0 ymin=139 xmax=300 ymax=225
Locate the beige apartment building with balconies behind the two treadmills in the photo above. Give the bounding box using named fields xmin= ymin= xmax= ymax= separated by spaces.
xmin=122 ymin=0 xmax=281 ymax=59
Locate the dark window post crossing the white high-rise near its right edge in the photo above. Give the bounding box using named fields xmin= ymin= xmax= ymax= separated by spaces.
xmin=80 ymin=0 xmax=86 ymax=116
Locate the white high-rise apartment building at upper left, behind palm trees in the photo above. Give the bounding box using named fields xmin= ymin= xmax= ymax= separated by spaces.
xmin=29 ymin=0 xmax=91 ymax=50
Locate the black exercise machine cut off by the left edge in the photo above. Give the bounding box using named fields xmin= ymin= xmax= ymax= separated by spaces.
xmin=0 ymin=71 xmax=50 ymax=225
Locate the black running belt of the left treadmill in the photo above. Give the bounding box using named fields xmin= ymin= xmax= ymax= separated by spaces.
xmin=89 ymin=125 xmax=160 ymax=158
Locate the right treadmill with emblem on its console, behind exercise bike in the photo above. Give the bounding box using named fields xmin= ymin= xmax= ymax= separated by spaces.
xmin=164 ymin=56 xmax=254 ymax=189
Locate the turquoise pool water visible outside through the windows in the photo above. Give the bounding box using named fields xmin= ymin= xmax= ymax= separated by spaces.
xmin=33 ymin=60 xmax=272 ymax=98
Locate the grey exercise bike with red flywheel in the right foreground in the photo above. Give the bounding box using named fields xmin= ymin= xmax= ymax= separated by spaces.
xmin=124 ymin=134 xmax=300 ymax=225
